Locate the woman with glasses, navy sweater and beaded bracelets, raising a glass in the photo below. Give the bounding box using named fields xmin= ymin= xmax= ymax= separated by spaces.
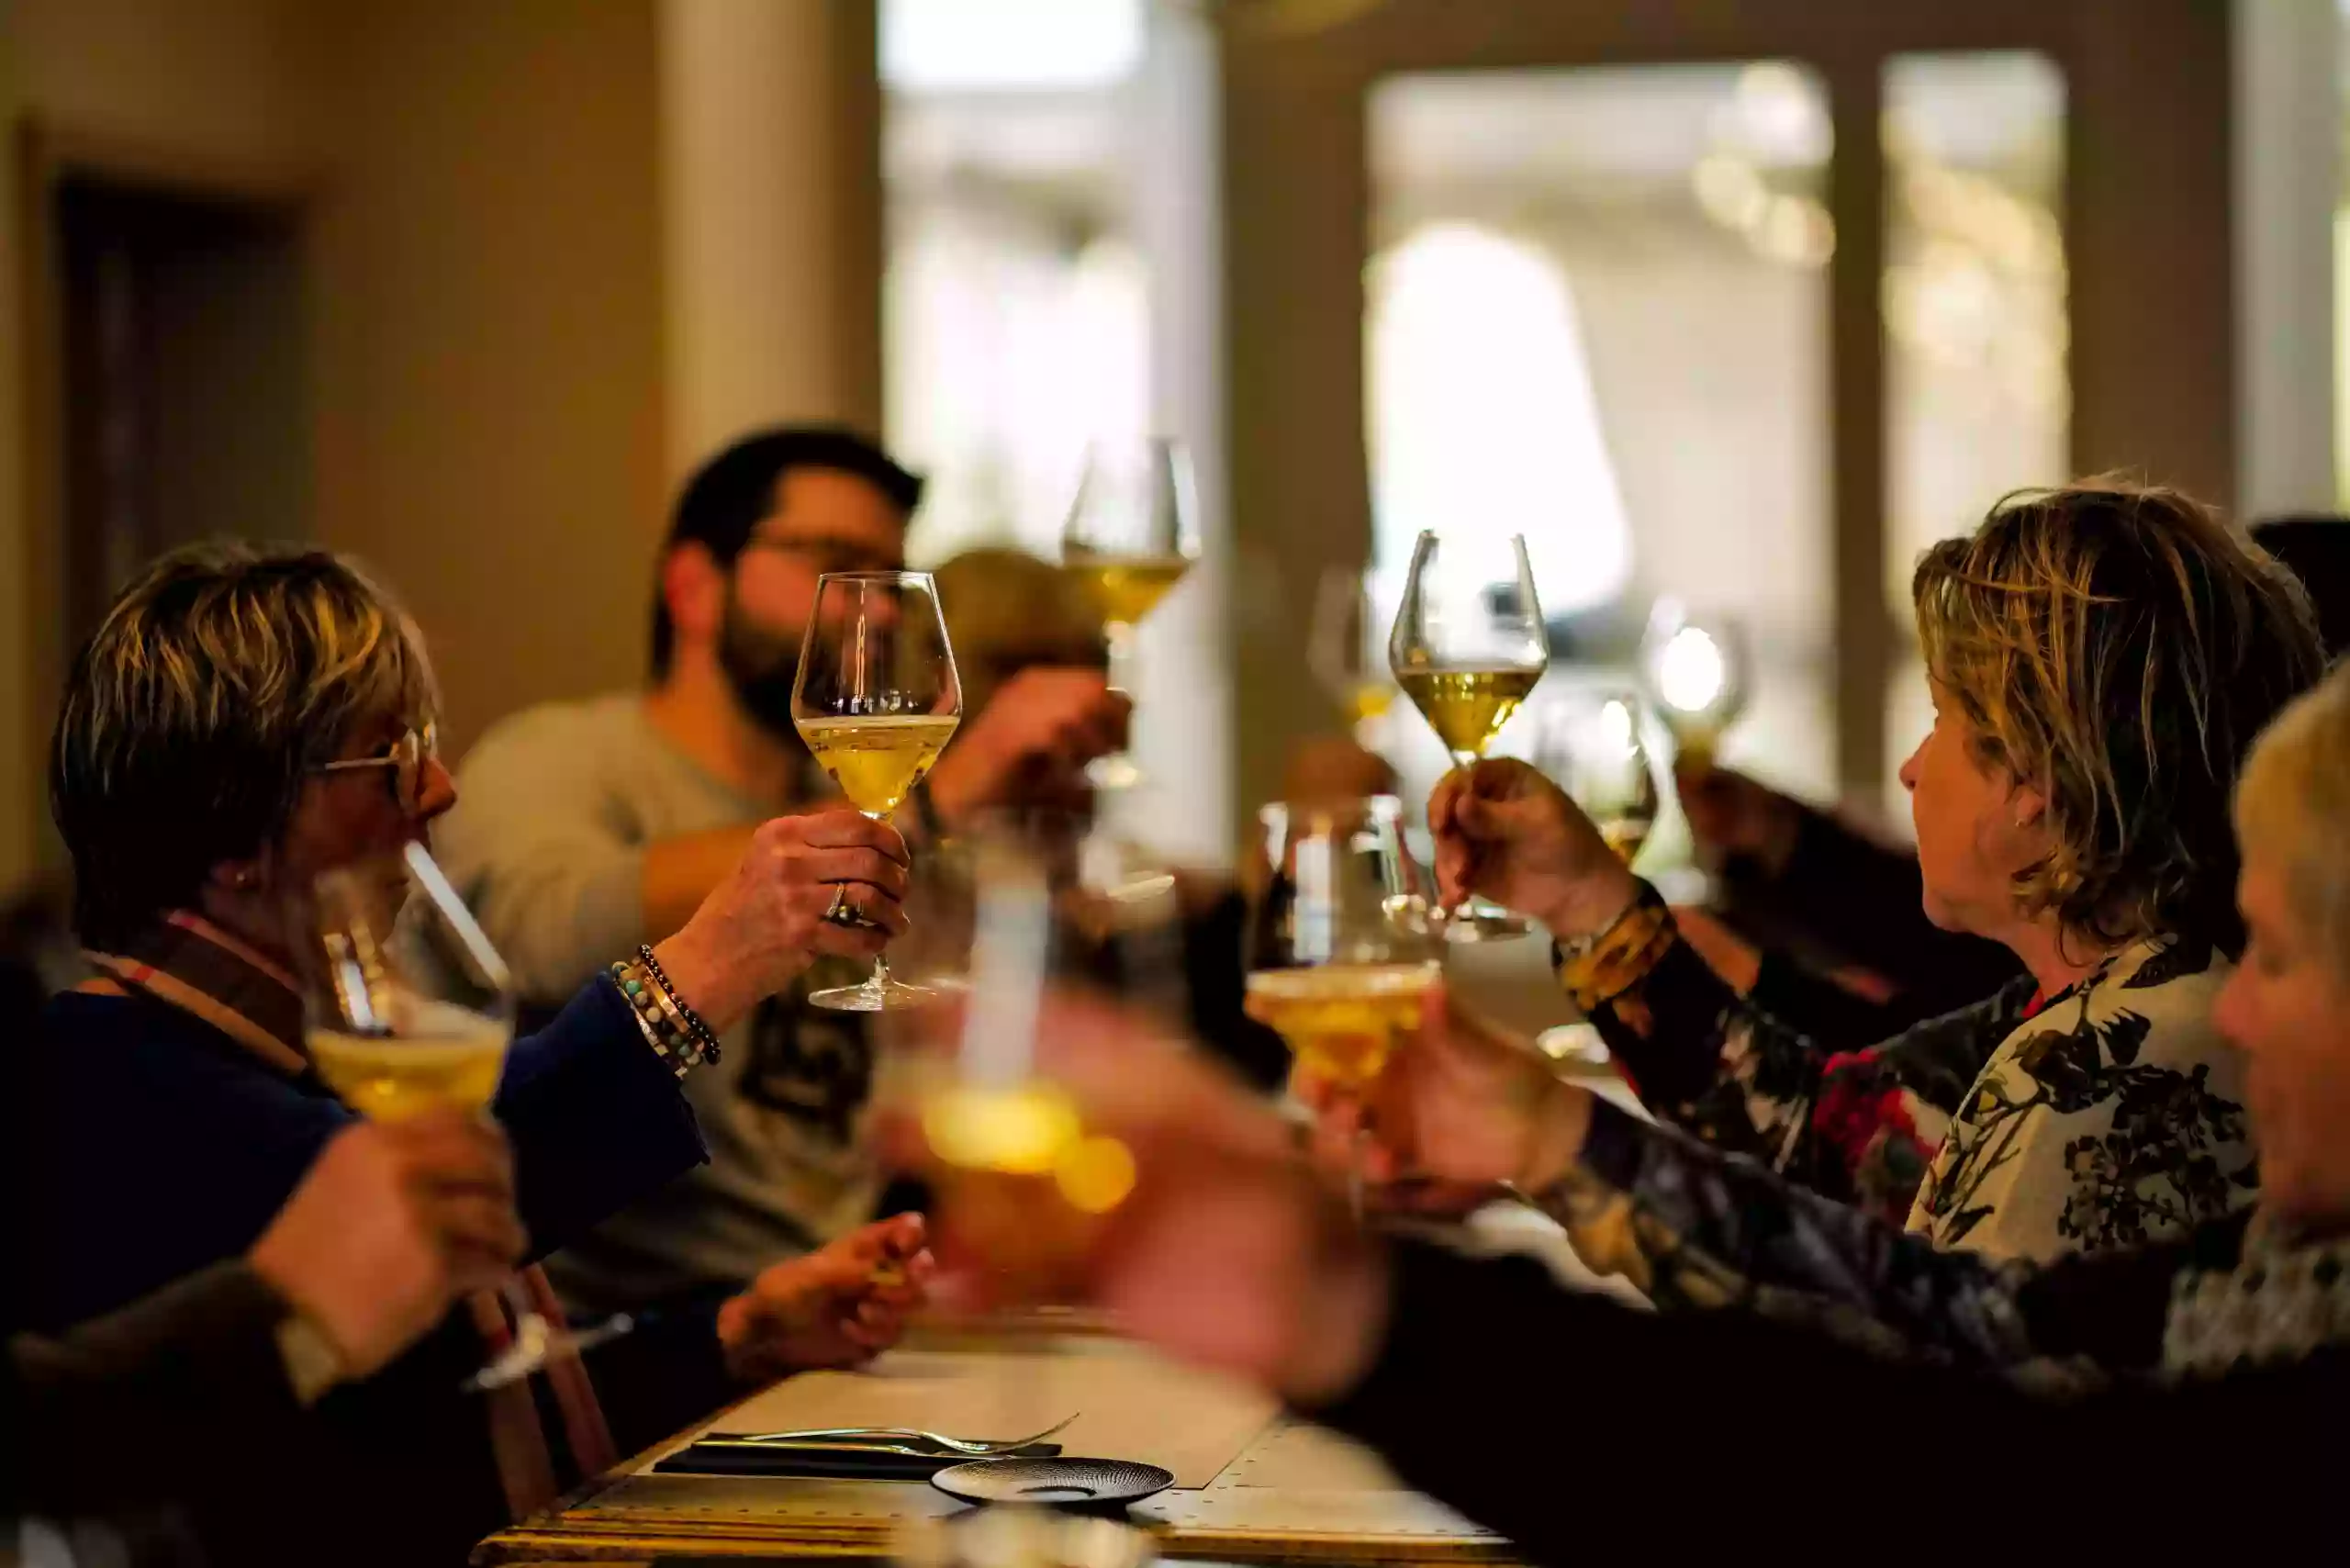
xmin=16 ymin=543 xmax=945 ymax=1563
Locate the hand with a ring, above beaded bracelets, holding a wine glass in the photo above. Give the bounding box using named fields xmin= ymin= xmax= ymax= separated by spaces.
xmin=654 ymin=806 xmax=907 ymax=1030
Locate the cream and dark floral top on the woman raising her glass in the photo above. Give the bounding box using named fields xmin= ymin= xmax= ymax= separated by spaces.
xmin=1561 ymin=893 xmax=2258 ymax=1262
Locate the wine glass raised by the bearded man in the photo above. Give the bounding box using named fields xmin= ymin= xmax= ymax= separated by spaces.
xmin=1060 ymin=437 xmax=1199 ymax=790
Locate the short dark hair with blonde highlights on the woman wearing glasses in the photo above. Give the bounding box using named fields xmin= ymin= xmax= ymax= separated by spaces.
xmin=50 ymin=543 xmax=437 ymax=947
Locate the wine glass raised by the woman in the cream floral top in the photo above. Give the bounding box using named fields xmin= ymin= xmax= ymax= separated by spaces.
xmin=1386 ymin=533 xmax=1551 ymax=943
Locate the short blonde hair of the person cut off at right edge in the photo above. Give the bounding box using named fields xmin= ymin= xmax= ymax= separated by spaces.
xmin=2235 ymin=658 xmax=2350 ymax=973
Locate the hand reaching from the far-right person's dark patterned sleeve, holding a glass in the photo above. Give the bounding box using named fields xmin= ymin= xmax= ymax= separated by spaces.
xmin=1290 ymin=990 xmax=1591 ymax=1217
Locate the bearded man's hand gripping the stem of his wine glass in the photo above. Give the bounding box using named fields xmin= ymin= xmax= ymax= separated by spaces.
xmin=928 ymin=666 xmax=1133 ymax=821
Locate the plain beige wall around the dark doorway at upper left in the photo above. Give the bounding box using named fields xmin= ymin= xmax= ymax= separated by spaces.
xmin=0 ymin=0 xmax=663 ymax=889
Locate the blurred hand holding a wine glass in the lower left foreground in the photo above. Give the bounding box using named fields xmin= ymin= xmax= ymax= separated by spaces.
xmin=247 ymin=1107 xmax=524 ymax=1378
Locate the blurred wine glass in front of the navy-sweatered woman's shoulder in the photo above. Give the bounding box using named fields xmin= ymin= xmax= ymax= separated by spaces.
xmin=289 ymin=842 xmax=634 ymax=1389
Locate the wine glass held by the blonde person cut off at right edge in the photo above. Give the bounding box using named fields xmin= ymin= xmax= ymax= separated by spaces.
xmin=1248 ymin=795 xmax=1443 ymax=1213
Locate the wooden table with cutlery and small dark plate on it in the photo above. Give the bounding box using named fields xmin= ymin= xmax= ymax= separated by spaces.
xmin=475 ymin=1335 xmax=1509 ymax=1568
